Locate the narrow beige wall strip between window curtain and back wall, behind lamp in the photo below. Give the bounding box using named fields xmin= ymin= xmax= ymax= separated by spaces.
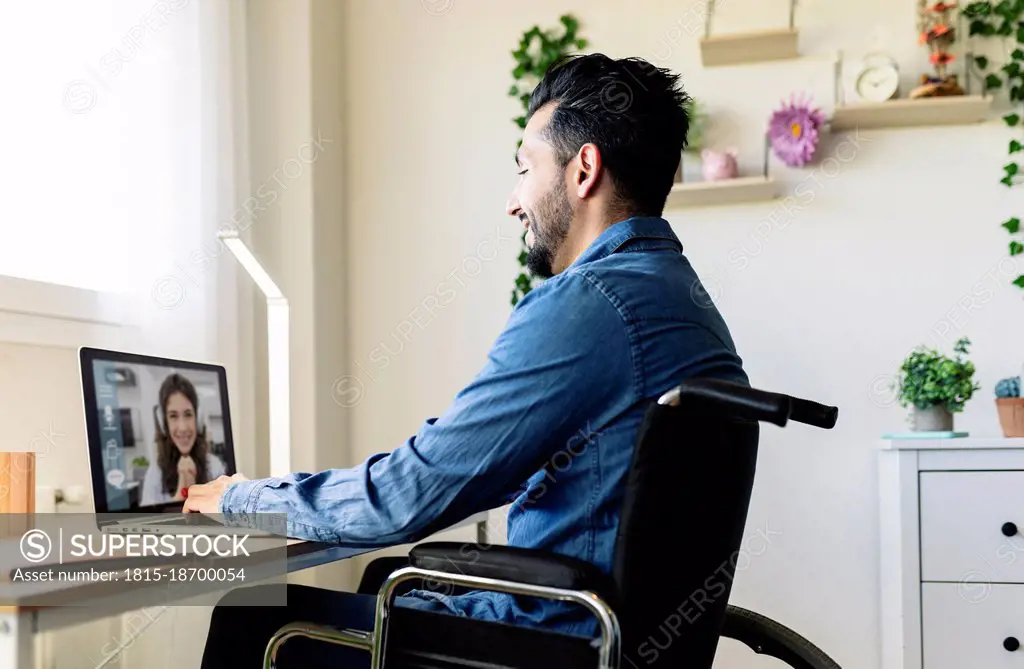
xmin=245 ymin=0 xmax=354 ymax=587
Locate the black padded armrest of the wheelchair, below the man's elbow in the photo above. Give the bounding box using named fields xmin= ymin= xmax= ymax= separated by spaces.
xmin=409 ymin=541 xmax=615 ymax=604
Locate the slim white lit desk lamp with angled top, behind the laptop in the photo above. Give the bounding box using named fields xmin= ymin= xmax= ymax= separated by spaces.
xmin=217 ymin=231 xmax=292 ymax=476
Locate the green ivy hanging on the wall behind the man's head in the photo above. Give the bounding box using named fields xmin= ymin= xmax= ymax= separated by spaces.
xmin=509 ymin=14 xmax=587 ymax=306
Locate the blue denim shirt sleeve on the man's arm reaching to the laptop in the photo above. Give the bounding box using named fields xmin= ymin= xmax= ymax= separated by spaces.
xmin=221 ymin=271 xmax=634 ymax=546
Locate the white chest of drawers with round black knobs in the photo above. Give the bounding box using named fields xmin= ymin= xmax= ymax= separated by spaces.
xmin=879 ymin=437 xmax=1024 ymax=669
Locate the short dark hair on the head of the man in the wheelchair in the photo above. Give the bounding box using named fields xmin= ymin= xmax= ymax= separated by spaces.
xmin=526 ymin=53 xmax=690 ymax=216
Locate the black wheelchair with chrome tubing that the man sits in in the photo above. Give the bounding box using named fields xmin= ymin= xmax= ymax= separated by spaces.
xmin=264 ymin=379 xmax=839 ymax=669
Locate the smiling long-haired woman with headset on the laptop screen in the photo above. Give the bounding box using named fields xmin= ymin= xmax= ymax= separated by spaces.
xmin=140 ymin=374 xmax=225 ymax=506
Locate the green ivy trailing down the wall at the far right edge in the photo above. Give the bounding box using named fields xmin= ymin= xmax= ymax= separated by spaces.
xmin=964 ymin=0 xmax=1024 ymax=288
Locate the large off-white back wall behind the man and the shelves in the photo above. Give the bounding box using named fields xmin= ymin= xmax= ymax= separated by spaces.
xmin=341 ymin=0 xmax=1024 ymax=667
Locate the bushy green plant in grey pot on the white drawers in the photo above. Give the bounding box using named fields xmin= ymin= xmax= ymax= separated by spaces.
xmin=898 ymin=337 xmax=981 ymax=432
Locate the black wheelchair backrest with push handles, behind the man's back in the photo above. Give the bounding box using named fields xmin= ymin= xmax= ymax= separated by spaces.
xmin=612 ymin=379 xmax=837 ymax=669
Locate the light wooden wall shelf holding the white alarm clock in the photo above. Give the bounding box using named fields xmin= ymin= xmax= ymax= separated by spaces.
xmin=829 ymin=95 xmax=992 ymax=132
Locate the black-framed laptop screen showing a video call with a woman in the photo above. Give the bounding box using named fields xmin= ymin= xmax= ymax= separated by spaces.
xmin=81 ymin=348 xmax=234 ymax=512
